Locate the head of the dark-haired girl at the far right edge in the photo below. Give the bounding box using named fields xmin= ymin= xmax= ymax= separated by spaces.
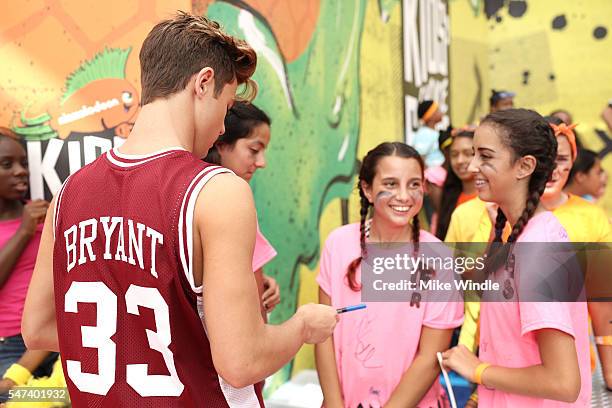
xmin=565 ymin=149 xmax=608 ymax=201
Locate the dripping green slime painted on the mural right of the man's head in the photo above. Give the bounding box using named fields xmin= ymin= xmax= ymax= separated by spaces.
xmin=207 ymin=0 xmax=366 ymax=390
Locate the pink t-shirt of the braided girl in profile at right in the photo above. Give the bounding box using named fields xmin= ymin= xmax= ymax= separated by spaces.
xmin=478 ymin=211 xmax=591 ymax=408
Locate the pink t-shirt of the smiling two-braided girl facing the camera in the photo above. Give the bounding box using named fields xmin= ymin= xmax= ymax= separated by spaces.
xmin=317 ymin=224 xmax=463 ymax=408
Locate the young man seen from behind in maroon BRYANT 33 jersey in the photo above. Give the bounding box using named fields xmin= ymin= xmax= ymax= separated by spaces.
xmin=22 ymin=13 xmax=338 ymax=407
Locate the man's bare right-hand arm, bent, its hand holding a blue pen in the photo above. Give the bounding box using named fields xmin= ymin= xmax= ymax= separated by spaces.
xmin=194 ymin=174 xmax=337 ymax=387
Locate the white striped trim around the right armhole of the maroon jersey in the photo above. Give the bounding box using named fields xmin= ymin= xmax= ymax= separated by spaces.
xmin=178 ymin=166 xmax=234 ymax=294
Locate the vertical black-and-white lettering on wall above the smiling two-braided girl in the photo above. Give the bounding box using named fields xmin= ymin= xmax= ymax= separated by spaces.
xmin=402 ymin=0 xmax=450 ymax=143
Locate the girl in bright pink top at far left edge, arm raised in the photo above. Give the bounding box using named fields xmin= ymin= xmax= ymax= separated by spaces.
xmin=0 ymin=127 xmax=56 ymax=402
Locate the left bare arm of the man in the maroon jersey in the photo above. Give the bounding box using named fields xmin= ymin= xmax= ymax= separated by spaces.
xmin=21 ymin=199 xmax=59 ymax=351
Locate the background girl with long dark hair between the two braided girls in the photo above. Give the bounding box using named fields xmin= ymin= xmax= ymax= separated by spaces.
xmin=436 ymin=127 xmax=476 ymax=240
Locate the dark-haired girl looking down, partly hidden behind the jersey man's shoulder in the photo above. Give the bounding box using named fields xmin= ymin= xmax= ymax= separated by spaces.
xmin=204 ymin=102 xmax=280 ymax=318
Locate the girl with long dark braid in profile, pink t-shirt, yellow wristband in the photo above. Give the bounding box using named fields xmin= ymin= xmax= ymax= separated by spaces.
xmin=443 ymin=109 xmax=591 ymax=408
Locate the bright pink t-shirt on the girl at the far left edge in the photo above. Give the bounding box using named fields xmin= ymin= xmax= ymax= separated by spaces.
xmin=0 ymin=218 xmax=42 ymax=337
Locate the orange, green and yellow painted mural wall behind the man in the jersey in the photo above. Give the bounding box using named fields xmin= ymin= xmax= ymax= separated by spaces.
xmin=0 ymin=0 xmax=416 ymax=384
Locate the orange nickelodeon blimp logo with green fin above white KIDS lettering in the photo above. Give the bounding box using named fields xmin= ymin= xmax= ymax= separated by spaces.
xmin=12 ymin=48 xmax=139 ymax=199
